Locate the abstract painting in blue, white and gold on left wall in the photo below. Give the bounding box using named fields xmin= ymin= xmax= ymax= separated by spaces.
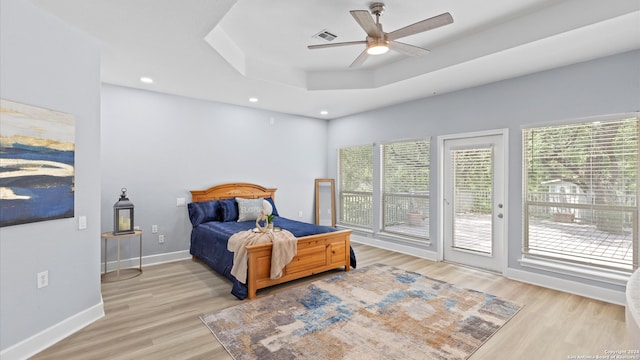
xmin=0 ymin=99 xmax=75 ymax=227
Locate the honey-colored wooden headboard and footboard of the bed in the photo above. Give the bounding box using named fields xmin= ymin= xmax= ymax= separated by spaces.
xmin=191 ymin=183 xmax=351 ymax=299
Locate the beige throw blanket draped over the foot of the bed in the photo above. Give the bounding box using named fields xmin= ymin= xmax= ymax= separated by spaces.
xmin=227 ymin=230 xmax=298 ymax=284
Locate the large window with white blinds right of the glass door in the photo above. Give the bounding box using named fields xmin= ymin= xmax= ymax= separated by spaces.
xmin=523 ymin=118 xmax=640 ymax=272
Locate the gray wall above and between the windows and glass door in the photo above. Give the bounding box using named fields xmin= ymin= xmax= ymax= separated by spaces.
xmin=327 ymin=51 xmax=640 ymax=290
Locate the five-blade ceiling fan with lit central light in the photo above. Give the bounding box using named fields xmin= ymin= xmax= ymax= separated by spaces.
xmin=307 ymin=2 xmax=453 ymax=67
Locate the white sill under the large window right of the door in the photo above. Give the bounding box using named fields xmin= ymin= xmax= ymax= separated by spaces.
xmin=519 ymin=256 xmax=631 ymax=286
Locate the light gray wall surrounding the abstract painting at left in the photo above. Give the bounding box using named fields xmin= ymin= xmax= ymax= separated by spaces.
xmin=0 ymin=0 xmax=102 ymax=350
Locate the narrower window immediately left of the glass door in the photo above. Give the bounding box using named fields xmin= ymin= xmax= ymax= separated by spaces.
xmin=380 ymin=140 xmax=430 ymax=239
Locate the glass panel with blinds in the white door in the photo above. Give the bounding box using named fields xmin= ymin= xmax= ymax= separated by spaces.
xmin=451 ymin=147 xmax=493 ymax=255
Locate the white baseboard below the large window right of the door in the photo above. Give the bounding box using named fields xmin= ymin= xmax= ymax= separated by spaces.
xmin=505 ymin=268 xmax=625 ymax=306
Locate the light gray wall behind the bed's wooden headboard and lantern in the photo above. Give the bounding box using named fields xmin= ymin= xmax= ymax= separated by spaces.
xmin=101 ymin=85 xmax=328 ymax=261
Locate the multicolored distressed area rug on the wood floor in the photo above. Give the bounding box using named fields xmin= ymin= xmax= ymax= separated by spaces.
xmin=200 ymin=264 xmax=520 ymax=360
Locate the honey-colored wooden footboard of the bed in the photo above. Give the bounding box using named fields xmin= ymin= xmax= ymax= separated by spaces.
xmin=247 ymin=230 xmax=351 ymax=299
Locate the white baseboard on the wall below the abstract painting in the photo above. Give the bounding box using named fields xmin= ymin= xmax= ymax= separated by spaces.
xmin=0 ymin=298 xmax=104 ymax=360
